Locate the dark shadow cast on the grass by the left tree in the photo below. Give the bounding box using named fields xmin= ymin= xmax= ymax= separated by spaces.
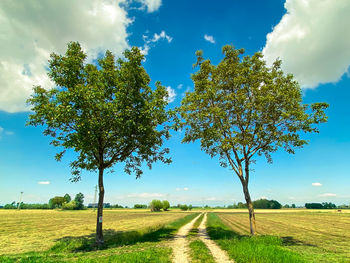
xmin=50 ymin=227 xmax=176 ymax=252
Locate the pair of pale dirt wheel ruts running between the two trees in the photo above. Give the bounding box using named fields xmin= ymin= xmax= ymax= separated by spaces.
xmin=172 ymin=213 xmax=234 ymax=263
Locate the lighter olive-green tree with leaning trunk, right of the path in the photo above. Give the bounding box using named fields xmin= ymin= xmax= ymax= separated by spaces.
xmin=176 ymin=46 xmax=328 ymax=235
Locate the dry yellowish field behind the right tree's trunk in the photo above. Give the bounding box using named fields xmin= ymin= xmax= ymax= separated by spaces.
xmin=217 ymin=210 xmax=350 ymax=262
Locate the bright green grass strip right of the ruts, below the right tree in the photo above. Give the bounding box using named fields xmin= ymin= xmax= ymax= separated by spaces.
xmin=207 ymin=213 xmax=307 ymax=263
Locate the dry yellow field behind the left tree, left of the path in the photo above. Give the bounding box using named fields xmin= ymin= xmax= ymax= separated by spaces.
xmin=0 ymin=209 xmax=187 ymax=255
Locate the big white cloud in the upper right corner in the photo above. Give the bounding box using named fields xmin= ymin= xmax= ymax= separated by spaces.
xmin=263 ymin=0 xmax=350 ymax=88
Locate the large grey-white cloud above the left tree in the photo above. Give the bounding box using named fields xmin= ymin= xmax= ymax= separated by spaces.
xmin=0 ymin=0 xmax=132 ymax=112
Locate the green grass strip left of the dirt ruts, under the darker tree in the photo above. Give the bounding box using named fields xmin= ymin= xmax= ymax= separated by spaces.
xmin=0 ymin=213 xmax=198 ymax=263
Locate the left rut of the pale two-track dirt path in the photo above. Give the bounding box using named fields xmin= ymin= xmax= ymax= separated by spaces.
xmin=171 ymin=214 xmax=200 ymax=263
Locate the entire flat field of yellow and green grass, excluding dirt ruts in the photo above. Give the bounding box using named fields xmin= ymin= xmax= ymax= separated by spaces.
xmin=0 ymin=209 xmax=350 ymax=263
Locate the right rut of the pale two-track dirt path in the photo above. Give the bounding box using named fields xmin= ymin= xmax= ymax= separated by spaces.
xmin=198 ymin=213 xmax=234 ymax=263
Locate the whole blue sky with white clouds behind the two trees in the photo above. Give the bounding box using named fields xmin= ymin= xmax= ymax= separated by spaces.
xmin=0 ymin=0 xmax=350 ymax=206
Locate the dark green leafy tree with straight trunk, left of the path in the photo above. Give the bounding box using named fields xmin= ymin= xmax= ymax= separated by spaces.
xmin=27 ymin=42 xmax=170 ymax=245
